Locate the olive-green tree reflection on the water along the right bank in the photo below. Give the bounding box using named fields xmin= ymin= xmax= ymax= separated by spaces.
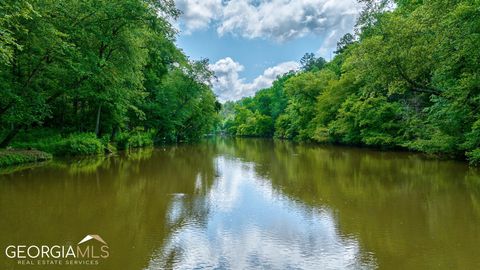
xmin=216 ymin=140 xmax=480 ymax=269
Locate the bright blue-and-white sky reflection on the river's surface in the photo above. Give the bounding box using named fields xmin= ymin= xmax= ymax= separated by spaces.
xmin=147 ymin=156 xmax=375 ymax=269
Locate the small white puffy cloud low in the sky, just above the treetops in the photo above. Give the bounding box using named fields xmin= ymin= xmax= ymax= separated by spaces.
xmin=210 ymin=57 xmax=300 ymax=101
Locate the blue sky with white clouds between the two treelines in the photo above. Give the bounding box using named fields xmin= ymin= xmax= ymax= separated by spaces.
xmin=175 ymin=0 xmax=360 ymax=102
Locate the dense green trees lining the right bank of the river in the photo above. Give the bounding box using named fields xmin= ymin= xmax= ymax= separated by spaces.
xmin=222 ymin=0 xmax=480 ymax=164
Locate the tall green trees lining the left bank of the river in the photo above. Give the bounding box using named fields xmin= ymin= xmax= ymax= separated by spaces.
xmin=0 ymin=0 xmax=220 ymax=153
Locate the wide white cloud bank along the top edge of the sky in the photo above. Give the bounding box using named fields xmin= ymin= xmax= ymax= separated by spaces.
xmin=176 ymin=0 xmax=359 ymax=45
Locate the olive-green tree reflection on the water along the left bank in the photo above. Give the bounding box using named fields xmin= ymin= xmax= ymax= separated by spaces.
xmin=0 ymin=145 xmax=215 ymax=269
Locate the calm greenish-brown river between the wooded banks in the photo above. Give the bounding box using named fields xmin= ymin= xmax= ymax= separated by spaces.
xmin=0 ymin=139 xmax=480 ymax=270
